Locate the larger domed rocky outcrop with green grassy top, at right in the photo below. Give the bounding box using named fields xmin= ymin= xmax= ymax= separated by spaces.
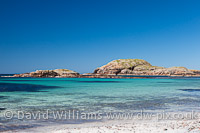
xmin=94 ymin=59 xmax=200 ymax=76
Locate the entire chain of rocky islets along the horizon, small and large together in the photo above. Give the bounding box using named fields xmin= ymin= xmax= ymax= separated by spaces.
xmin=13 ymin=59 xmax=200 ymax=78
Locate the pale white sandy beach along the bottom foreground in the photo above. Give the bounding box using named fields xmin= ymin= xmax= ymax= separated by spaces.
xmin=4 ymin=120 xmax=200 ymax=133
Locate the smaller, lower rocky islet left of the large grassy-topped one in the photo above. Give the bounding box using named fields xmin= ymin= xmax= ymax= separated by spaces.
xmin=14 ymin=69 xmax=79 ymax=78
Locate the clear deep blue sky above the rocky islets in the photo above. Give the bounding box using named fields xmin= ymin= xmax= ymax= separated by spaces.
xmin=0 ymin=0 xmax=200 ymax=73
